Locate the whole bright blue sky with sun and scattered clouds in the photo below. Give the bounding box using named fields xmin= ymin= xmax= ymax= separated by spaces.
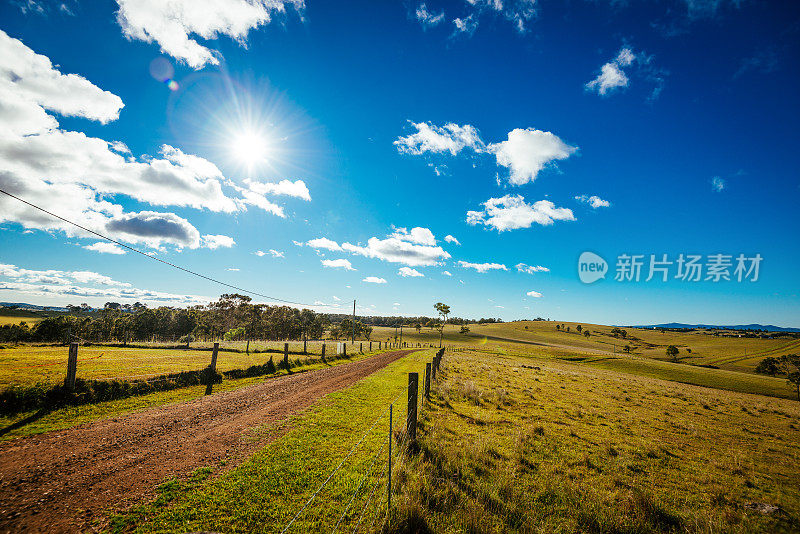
xmin=0 ymin=0 xmax=800 ymax=326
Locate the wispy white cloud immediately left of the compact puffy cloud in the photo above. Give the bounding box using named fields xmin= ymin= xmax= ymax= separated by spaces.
xmin=394 ymin=121 xmax=483 ymax=156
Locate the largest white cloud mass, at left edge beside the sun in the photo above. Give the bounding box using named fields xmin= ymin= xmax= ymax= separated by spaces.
xmin=0 ymin=30 xmax=288 ymax=248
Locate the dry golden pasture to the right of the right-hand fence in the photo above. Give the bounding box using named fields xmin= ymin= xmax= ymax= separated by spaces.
xmin=389 ymin=352 xmax=800 ymax=533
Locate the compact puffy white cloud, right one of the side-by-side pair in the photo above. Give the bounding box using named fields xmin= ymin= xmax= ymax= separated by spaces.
xmin=487 ymin=128 xmax=578 ymax=185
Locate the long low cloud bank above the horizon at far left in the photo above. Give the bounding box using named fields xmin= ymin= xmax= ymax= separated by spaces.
xmin=0 ymin=264 xmax=211 ymax=305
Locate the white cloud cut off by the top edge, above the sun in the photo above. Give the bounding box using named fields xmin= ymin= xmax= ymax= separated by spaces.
xmin=117 ymin=0 xmax=304 ymax=69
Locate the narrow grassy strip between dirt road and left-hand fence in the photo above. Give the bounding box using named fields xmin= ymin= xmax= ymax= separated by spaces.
xmin=0 ymin=354 xmax=382 ymax=441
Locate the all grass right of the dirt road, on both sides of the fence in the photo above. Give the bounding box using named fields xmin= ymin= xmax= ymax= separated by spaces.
xmin=112 ymin=350 xmax=800 ymax=533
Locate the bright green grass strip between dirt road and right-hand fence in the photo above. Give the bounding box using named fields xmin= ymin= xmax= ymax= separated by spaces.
xmin=110 ymin=350 xmax=433 ymax=532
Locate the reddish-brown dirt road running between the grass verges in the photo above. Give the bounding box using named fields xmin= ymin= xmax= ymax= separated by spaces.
xmin=0 ymin=350 xmax=413 ymax=532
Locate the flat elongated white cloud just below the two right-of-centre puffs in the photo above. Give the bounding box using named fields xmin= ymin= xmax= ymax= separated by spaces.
xmin=467 ymin=195 xmax=575 ymax=232
